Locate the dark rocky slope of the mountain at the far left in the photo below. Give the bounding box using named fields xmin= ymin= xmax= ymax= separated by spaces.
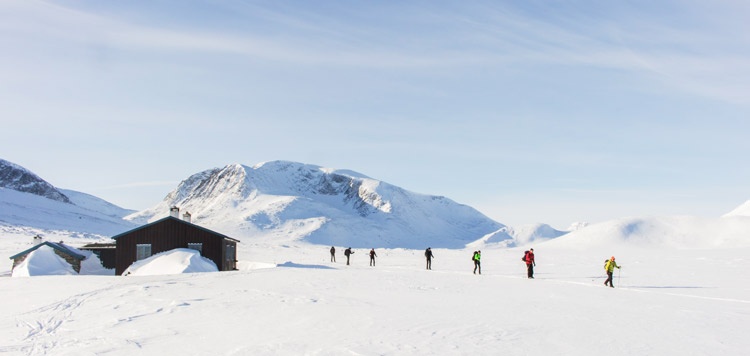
xmin=0 ymin=159 xmax=70 ymax=203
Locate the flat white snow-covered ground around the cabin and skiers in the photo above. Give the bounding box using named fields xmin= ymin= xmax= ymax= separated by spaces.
xmin=0 ymin=228 xmax=750 ymax=355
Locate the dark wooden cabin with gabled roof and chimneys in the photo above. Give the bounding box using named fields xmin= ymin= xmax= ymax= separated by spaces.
xmin=112 ymin=216 xmax=239 ymax=275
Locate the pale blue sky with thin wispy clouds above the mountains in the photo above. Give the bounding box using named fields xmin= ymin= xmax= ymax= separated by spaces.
xmin=0 ymin=0 xmax=750 ymax=228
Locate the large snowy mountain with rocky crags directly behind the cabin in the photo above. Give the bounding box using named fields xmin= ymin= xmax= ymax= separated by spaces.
xmin=126 ymin=161 xmax=510 ymax=248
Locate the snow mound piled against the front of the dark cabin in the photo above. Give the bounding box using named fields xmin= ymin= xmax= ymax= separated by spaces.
xmin=122 ymin=248 xmax=219 ymax=276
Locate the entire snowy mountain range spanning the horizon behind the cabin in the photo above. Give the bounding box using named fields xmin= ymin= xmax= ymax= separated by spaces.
xmin=0 ymin=160 xmax=750 ymax=248
